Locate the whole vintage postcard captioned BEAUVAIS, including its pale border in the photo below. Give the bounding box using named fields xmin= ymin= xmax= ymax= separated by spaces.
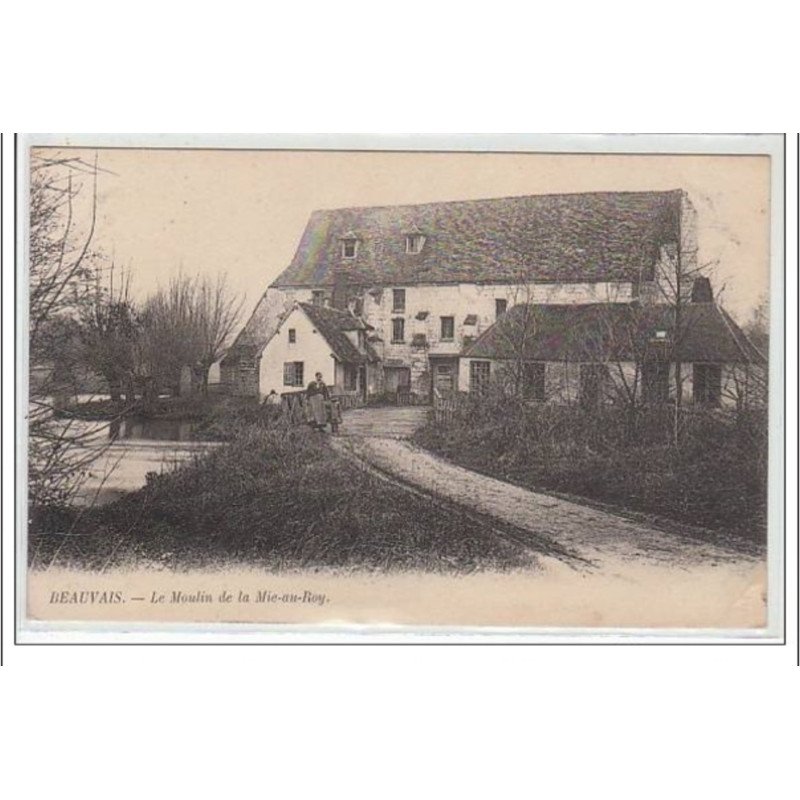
xmin=17 ymin=135 xmax=784 ymax=640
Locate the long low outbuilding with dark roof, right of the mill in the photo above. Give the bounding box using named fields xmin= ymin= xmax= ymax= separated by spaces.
xmin=459 ymin=290 xmax=767 ymax=407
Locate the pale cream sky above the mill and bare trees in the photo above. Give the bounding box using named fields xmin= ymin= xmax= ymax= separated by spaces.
xmin=32 ymin=148 xmax=770 ymax=321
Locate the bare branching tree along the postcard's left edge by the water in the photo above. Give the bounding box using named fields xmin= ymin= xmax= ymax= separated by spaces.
xmin=28 ymin=152 xmax=115 ymax=507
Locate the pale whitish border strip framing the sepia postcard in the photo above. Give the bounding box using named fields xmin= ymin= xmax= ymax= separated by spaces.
xmin=14 ymin=134 xmax=788 ymax=644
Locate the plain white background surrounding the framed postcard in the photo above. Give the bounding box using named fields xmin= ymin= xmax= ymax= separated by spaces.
xmin=0 ymin=0 xmax=800 ymax=799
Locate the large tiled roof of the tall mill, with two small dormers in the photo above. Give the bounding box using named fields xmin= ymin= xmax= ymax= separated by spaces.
xmin=272 ymin=190 xmax=683 ymax=287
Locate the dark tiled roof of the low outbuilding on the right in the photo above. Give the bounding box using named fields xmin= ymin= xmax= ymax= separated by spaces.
xmin=463 ymin=303 xmax=766 ymax=365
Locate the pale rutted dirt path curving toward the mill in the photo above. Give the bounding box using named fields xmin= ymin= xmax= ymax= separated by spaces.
xmin=333 ymin=408 xmax=755 ymax=568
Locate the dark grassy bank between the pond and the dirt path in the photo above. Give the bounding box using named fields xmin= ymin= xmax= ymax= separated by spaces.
xmin=29 ymin=422 xmax=535 ymax=573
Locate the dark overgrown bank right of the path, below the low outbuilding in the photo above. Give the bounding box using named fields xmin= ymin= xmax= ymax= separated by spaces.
xmin=416 ymin=398 xmax=767 ymax=543
